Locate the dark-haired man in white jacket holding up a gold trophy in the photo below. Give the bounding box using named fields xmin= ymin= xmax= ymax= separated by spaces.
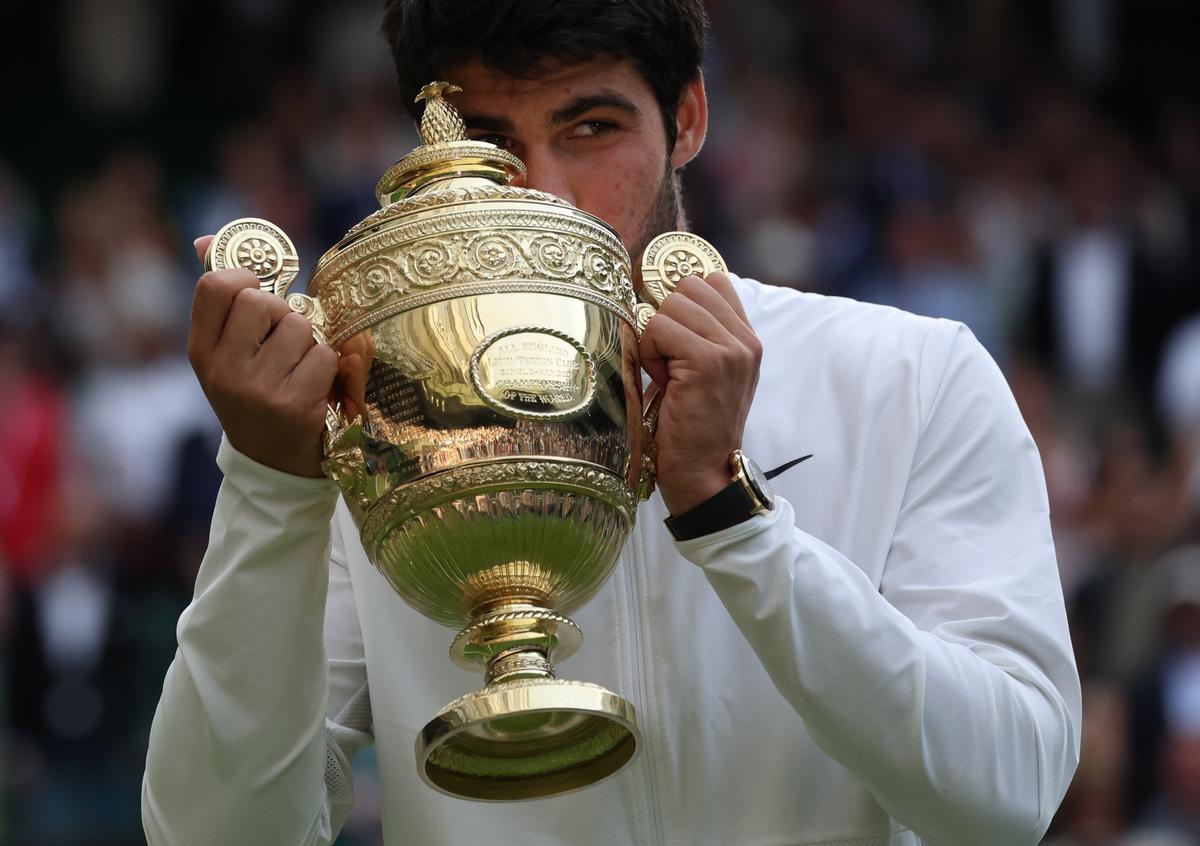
xmin=143 ymin=0 xmax=1080 ymax=846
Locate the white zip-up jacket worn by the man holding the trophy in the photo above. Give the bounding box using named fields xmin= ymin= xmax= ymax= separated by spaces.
xmin=143 ymin=280 xmax=1080 ymax=846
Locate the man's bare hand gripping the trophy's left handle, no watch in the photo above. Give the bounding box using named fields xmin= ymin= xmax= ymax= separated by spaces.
xmin=187 ymin=235 xmax=337 ymax=478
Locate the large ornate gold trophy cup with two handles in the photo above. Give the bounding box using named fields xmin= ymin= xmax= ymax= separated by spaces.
xmin=206 ymin=83 xmax=725 ymax=800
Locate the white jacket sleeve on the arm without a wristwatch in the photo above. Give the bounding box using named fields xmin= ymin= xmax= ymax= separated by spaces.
xmin=142 ymin=442 xmax=372 ymax=846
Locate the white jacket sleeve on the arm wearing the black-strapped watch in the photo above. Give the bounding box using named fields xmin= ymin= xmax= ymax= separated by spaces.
xmin=678 ymin=329 xmax=1080 ymax=846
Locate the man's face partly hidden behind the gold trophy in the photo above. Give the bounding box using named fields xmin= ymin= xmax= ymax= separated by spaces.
xmin=446 ymin=59 xmax=696 ymax=262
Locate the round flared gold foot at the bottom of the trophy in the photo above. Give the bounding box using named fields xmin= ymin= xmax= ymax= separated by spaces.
xmin=416 ymin=678 xmax=641 ymax=802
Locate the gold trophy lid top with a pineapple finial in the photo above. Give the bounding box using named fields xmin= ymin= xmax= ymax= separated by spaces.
xmin=376 ymin=82 xmax=526 ymax=206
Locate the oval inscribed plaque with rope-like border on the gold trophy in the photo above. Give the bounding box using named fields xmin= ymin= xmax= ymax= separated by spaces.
xmin=470 ymin=326 xmax=596 ymax=420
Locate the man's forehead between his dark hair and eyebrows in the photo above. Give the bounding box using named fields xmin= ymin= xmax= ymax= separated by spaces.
xmin=446 ymin=56 xmax=654 ymax=119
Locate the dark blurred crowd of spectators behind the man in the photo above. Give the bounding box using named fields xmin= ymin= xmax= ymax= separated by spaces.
xmin=0 ymin=0 xmax=1200 ymax=846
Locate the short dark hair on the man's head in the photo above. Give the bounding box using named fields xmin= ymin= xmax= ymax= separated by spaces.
xmin=383 ymin=0 xmax=706 ymax=150
